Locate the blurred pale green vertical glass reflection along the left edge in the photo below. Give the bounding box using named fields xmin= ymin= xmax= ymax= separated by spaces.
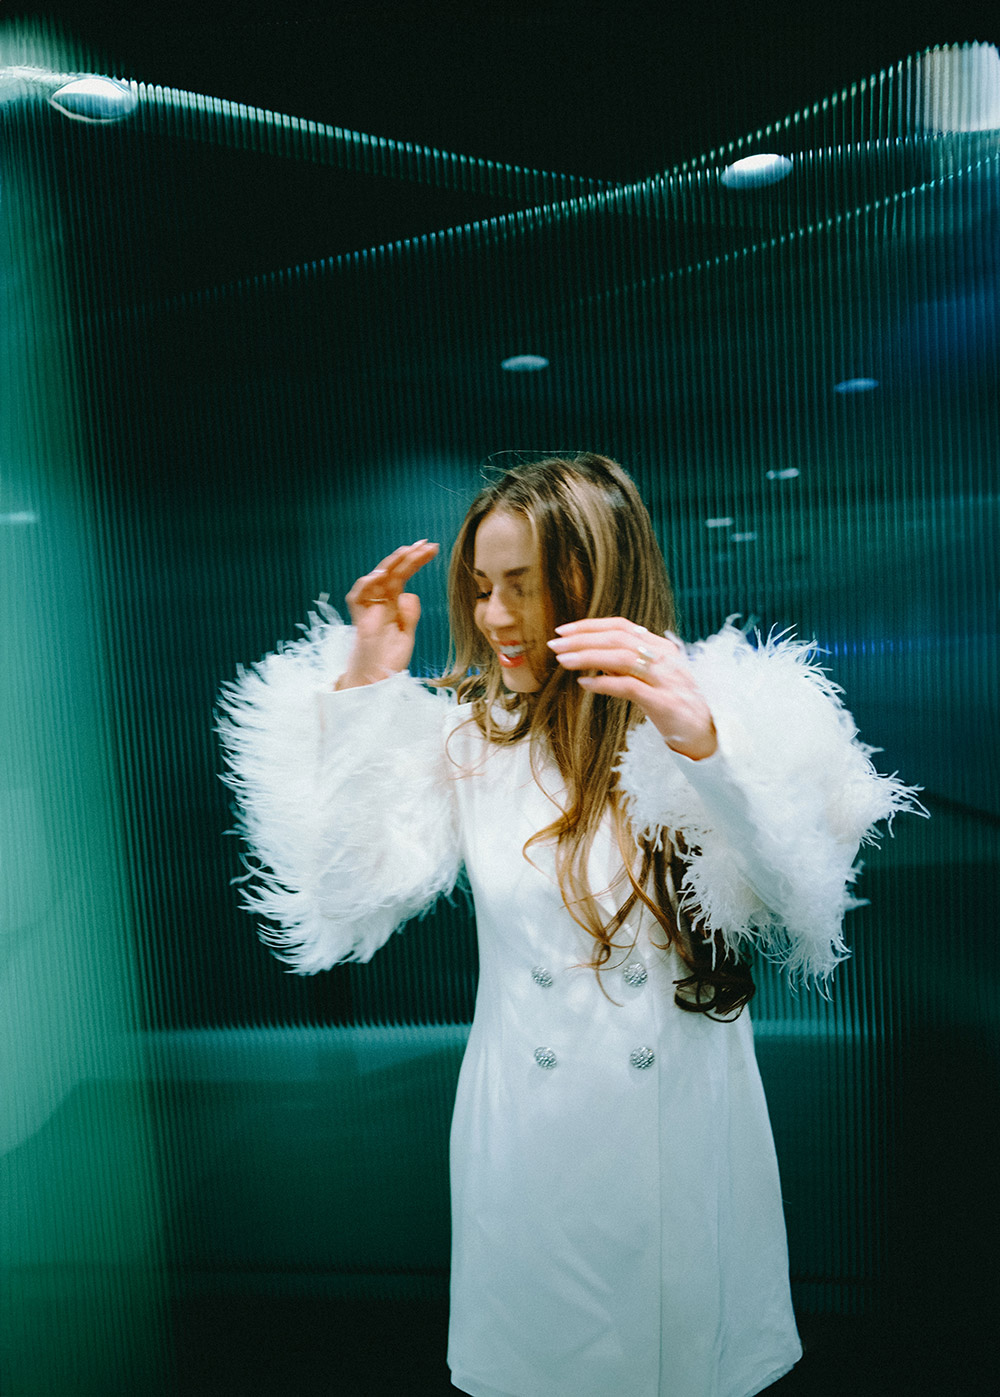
xmin=0 ymin=21 xmax=165 ymax=1397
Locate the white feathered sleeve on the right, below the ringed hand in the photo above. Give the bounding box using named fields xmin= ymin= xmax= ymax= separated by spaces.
xmin=619 ymin=623 xmax=926 ymax=979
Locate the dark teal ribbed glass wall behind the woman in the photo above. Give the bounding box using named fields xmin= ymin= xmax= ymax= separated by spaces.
xmin=0 ymin=16 xmax=1000 ymax=1397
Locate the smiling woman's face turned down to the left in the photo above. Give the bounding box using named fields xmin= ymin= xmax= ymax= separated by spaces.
xmin=472 ymin=510 xmax=553 ymax=694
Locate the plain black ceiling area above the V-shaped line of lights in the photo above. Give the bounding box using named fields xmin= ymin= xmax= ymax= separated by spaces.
xmin=4 ymin=0 xmax=1000 ymax=188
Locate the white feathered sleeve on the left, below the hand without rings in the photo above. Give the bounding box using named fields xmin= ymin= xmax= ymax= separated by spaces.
xmin=218 ymin=598 xmax=459 ymax=975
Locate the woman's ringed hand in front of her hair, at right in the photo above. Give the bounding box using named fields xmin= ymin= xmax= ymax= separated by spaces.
xmin=549 ymin=616 xmax=718 ymax=761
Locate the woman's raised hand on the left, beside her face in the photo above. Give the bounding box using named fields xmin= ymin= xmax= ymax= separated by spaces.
xmin=337 ymin=538 xmax=439 ymax=689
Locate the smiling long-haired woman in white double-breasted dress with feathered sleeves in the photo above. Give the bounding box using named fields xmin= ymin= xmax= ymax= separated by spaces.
xmin=222 ymin=455 xmax=913 ymax=1397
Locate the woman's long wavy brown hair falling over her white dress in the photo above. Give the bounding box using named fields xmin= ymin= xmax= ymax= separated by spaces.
xmin=437 ymin=454 xmax=754 ymax=1020
